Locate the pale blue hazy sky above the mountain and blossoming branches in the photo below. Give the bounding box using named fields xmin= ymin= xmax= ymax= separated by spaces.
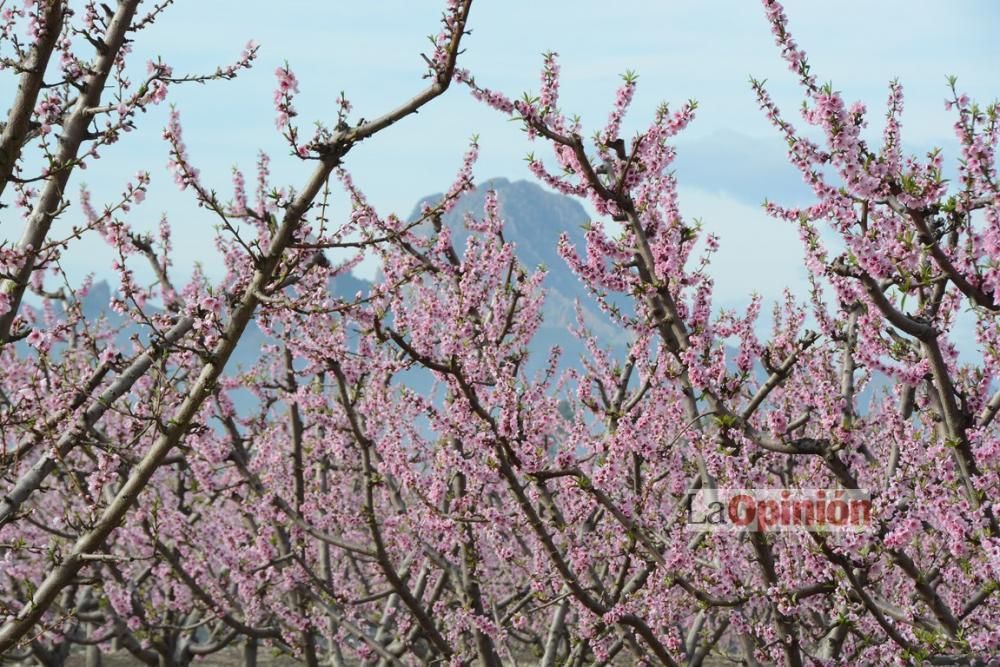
xmin=9 ymin=0 xmax=1000 ymax=314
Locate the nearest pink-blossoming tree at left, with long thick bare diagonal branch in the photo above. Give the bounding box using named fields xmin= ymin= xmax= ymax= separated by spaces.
xmin=0 ymin=0 xmax=470 ymax=653
